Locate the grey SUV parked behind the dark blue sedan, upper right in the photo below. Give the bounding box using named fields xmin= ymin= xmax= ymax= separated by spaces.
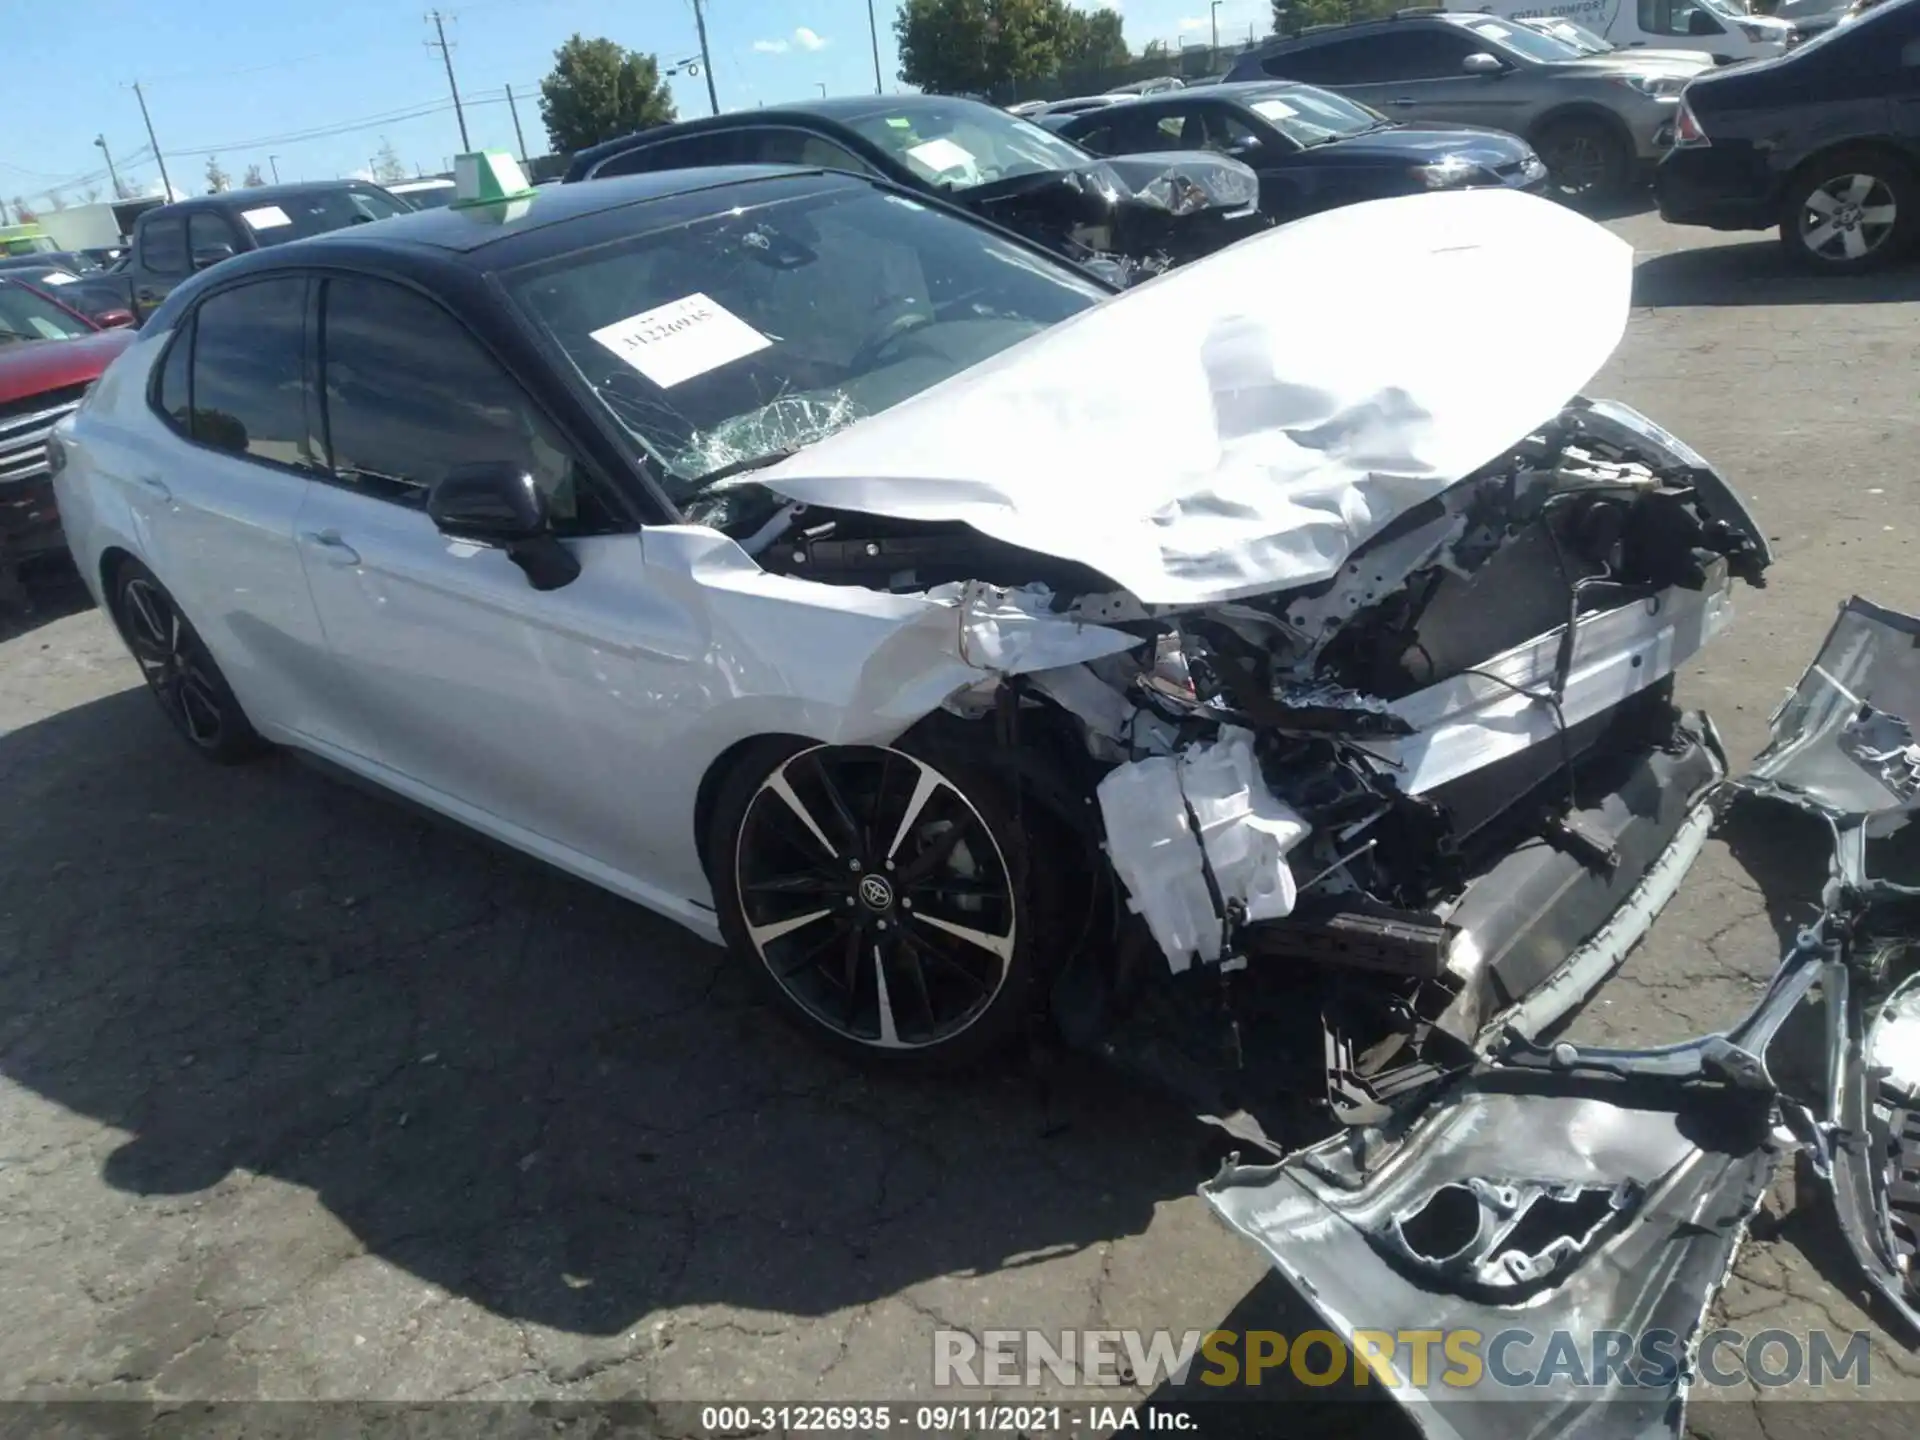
xmin=1229 ymin=12 xmax=1713 ymax=200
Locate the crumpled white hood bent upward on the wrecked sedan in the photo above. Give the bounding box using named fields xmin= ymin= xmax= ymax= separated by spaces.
xmin=756 ymin=190 xmax=1632 ymax=605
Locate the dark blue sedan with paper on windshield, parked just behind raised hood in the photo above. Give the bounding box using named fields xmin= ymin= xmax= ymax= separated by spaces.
xmin=1060 ymin=81 xmax=1548 ymax=221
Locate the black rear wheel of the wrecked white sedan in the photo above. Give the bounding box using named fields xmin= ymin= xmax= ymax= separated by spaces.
xmin=113 ymin=561 xmax=267 ymax=764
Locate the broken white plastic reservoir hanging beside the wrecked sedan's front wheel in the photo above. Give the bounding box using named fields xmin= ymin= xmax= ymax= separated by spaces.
xmin=1098 ymin=726 xmax=1311 ymax=973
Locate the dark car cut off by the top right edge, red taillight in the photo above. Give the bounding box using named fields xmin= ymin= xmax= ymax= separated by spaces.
xmin=1655 ymin=0 xmax=1920 ymax=273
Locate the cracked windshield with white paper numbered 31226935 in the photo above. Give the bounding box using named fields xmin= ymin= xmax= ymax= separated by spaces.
xmin=509 ymin=184 xmax=1104 ymax=501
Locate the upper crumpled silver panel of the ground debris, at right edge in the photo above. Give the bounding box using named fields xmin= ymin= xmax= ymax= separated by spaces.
xmin=1740 ymin=595 xmax=1920 ymax=835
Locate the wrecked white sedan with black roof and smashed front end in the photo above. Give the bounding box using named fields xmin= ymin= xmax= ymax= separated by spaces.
xmin=54 ymin=160 xmax=1768 ymax=1140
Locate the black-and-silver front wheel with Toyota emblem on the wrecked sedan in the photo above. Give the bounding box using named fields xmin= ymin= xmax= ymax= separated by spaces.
xmin=708 ymin=741 xmax=1039 ymax=1069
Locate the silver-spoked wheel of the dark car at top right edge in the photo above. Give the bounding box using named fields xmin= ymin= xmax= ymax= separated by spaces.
xmin=1780 ymin=150 xmax=1920 ymax=275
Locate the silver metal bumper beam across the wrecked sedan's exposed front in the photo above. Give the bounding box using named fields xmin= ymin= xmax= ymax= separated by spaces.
xmin=1361 ymin=572 xmax=1734 ymax=795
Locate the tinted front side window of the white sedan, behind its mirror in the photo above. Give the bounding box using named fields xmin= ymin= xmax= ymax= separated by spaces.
xmin=321 ymin=278 xmax=612 ymax=534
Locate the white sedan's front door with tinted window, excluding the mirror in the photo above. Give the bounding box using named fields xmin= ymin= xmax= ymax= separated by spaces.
xmin=298 ymin=276 xmax=701 ymax=879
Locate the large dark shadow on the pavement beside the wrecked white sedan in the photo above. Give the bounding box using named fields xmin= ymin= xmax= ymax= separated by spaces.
xmin=0 ymin=689 xmax=1204 ymax=1334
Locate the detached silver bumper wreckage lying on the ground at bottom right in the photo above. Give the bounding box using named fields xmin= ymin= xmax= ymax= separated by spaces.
xmin=1202 ymin=599 xmax=1920 ymax=1440
